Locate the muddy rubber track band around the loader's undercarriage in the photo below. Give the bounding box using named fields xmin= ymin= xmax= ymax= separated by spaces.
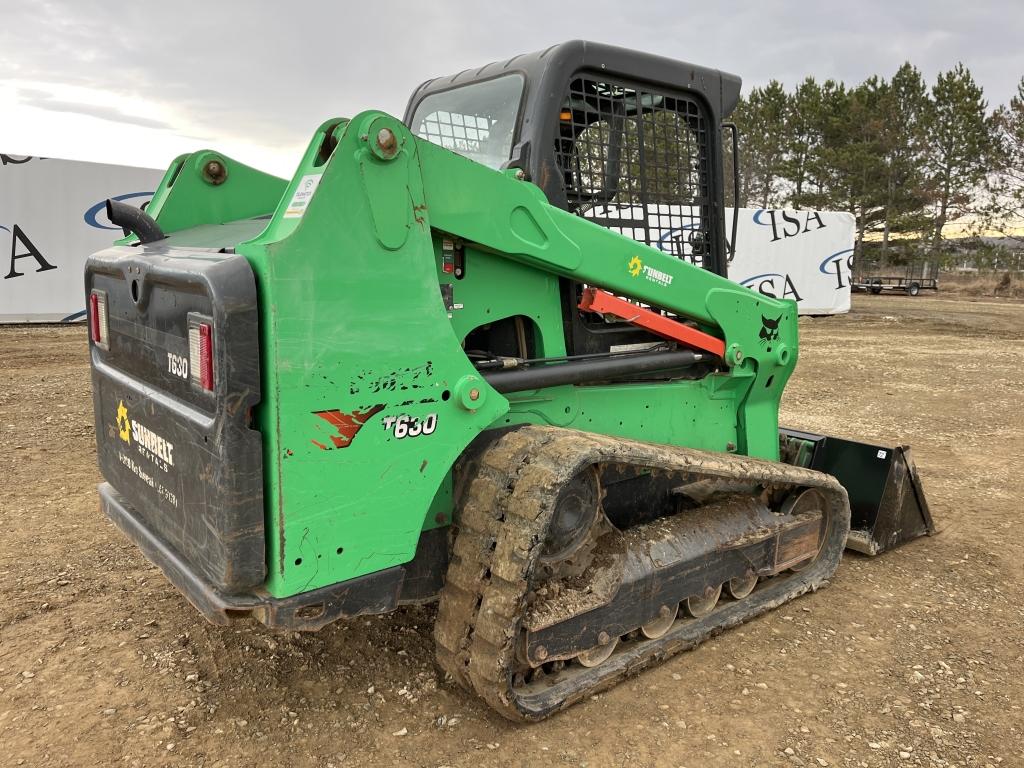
xmin=434 ymin=426 xmax=850 ymax=721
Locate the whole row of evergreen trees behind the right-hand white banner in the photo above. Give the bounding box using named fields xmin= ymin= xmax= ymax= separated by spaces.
xmin=727 ymin=62 xmax=1024 ymax=261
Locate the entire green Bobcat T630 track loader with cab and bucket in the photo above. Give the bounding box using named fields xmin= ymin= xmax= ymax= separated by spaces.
xmin=86 ymin=41 xmax=932 ymax=720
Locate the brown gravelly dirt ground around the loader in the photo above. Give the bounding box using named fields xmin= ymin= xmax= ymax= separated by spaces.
xmin=0 ymin=296 xmax=1024 ymax=768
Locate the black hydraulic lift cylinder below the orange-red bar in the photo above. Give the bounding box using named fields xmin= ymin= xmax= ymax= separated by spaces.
xmin=480 ymin=349 xmax=713 ymax=392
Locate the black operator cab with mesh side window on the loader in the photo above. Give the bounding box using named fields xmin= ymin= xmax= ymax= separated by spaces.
xmin=404 ymin=40 xmax=740 ymax=354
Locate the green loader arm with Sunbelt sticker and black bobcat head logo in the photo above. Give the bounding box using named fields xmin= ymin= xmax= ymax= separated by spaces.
xmin=409 ymin=128 xmax=798 ymax=460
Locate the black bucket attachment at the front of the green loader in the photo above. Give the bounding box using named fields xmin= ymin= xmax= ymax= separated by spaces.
xmin=779 ymin=429 xmax=935 ymax=555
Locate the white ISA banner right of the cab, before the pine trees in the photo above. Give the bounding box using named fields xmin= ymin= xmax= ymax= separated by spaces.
xmin=725 ymin=208 xmax=856 ymax=314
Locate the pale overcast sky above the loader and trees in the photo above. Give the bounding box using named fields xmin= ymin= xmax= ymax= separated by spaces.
xmin=0 ymin=0 xmax=1024 ymax=176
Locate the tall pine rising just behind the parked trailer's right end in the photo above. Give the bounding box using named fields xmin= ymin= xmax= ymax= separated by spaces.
xmin=928 ymin=63 xmax=992 ymax=250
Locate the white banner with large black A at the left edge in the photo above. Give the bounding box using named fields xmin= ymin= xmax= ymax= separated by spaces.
xmin=0 ymin=155 xmax=164 ymax=323
